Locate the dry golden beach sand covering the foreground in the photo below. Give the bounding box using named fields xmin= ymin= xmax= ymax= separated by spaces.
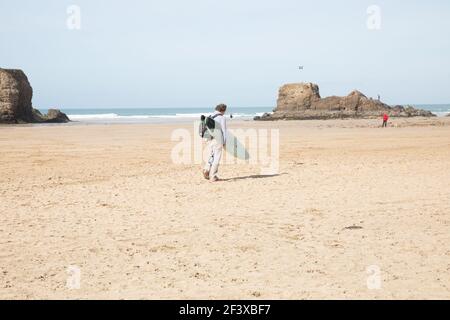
xmin=0 ymin=119 xmax=450 ymax=299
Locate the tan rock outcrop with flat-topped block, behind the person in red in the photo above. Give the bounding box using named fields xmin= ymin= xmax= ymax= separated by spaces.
xmin=255 ymin=83 xmax=434 ymax=120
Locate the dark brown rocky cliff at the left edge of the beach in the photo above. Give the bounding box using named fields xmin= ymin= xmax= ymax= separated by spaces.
xmin=0 ymin=68 xmax=70 ymax=123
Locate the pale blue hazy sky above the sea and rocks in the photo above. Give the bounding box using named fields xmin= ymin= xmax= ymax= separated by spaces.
xmin=0 ymin=0 xmax=450 ymax=108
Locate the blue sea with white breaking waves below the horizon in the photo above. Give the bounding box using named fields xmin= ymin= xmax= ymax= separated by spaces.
xmin=40 ymin=104 xmax=450 ymax=124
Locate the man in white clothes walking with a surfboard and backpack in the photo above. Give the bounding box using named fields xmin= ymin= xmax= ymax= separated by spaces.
xmin=203 ymin=104 xmax=227 ymax=182
